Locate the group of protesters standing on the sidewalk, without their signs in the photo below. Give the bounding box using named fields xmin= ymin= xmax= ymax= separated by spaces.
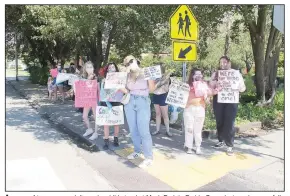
xmin=47 ymin=55 xmax=246 ymax=167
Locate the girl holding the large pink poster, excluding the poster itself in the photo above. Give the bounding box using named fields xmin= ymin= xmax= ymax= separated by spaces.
xmin=81 ymin=61 xmax=99 ymax=140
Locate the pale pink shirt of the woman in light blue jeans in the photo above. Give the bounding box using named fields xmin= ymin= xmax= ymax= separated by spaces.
xmin=127 ymin=79 xmax=149 ymax=96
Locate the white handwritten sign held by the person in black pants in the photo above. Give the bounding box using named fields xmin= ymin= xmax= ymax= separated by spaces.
xmin=218 ymin=70 xmax=240 ymax=103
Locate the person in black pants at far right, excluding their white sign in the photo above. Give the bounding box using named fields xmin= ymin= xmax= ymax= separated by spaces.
xmin=210 ymin=56 xmax=246 ymax=156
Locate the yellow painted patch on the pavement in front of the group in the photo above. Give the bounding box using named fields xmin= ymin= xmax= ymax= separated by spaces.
xmin=115 ymin=148 xmax=260 ymax=191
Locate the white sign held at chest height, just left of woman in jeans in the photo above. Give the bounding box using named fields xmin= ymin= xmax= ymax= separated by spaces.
xmin=104 ymin=72 xmax=127 ymax=89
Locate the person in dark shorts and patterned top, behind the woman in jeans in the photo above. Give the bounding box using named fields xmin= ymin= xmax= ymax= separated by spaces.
xmin=152 ymin=65 xmax=172 ymax=137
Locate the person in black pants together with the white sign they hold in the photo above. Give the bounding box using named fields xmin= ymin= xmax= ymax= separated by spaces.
xmin=210 ymin=56 xmax=246 ymax=156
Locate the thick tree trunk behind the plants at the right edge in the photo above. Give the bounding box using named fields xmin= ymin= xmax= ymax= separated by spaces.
xmin=237 ymin=5 xmax=282 ymax=105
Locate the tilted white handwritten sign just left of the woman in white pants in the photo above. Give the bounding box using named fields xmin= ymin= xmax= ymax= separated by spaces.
xmin=166 ymin=79 xmax=190 ymax=108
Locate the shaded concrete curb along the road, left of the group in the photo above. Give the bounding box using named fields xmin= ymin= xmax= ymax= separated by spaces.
xmin=6 ymin=81 xmax=100 ymax=151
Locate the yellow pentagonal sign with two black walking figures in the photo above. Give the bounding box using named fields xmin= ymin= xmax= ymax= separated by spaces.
xmin=170 ymin=5 xmax=198 ymax=41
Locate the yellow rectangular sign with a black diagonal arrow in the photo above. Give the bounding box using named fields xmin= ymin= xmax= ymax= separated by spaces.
xmin=172 ymin=41 xmax=197 ymax=61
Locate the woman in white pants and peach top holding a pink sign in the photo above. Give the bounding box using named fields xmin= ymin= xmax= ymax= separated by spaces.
xmin=183 ymin=69 xmax=213 ymax=154
